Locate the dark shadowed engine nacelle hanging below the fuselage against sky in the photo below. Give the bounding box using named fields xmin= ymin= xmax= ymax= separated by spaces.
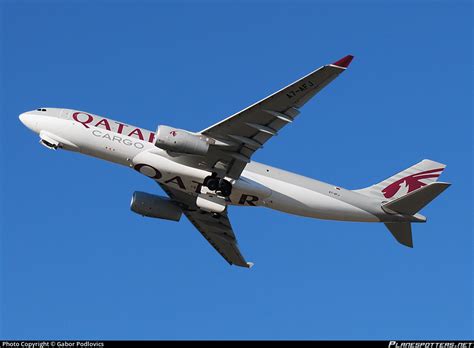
xmin=130 ymin=191 xmax=183 ymax=221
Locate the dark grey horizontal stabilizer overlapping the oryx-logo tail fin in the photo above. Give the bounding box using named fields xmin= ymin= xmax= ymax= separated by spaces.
xmin=382 ymin=182 xmax=451 ymax=216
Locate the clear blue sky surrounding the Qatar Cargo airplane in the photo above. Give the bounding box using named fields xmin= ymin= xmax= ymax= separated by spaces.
xmin=0 ymin=1 xmax=474 ymax=339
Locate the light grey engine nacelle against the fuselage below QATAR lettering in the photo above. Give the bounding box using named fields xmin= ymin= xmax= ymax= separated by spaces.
xmin=155 ymin=126 xmax=209 ymax=155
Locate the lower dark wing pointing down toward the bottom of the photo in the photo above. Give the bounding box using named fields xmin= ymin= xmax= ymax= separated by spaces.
xmin=160 ymin=184 xmax=253 ymax=268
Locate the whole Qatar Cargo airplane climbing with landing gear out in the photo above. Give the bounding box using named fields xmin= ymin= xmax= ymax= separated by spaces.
xmin=19 ymin=55 xmax=450 ymax=268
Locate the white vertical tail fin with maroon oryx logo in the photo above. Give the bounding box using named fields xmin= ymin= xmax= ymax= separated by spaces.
xmin=355 ymin=159 xmax=446 ymax=201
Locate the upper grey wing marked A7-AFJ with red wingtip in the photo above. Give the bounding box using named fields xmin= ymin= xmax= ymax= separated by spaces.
xmin=200 ymin=55 xmax=353 ymax=179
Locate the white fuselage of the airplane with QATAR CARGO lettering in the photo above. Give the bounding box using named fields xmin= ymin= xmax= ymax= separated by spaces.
xmin=20 ymin=108 xmax=399 ymax=222
